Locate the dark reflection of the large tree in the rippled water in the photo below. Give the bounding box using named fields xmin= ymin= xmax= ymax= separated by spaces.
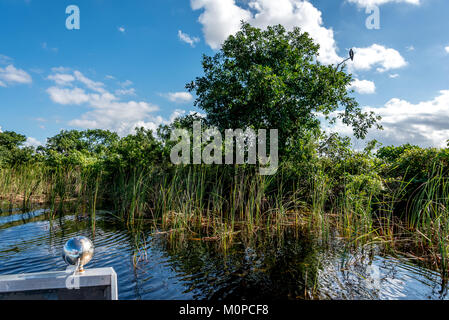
xmin=158 ymin=230 xmax=317 ymax=300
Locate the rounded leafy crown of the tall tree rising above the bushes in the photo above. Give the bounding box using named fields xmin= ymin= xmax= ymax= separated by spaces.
xmin=186 ymin=23 xmax=379 ymax=159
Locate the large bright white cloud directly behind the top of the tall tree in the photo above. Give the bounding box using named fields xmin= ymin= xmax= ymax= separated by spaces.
xmin=191 ymin=0 xmax=341 ymax=64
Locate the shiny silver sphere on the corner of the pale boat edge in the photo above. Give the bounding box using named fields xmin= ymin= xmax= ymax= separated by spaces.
xmin=62 ymin=237 xmax=94 ymax=272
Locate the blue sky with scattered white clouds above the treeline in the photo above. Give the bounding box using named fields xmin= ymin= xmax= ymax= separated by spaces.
xmin=0 ymin=0 xmax=449 ymax=146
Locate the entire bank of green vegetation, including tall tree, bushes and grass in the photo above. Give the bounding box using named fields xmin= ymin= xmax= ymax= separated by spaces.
xmin=0 ymin=24 xmax=449 ymax=267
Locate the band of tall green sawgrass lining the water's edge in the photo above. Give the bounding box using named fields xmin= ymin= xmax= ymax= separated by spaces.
xmin=0 ymin=157 xmax=449 ymax=271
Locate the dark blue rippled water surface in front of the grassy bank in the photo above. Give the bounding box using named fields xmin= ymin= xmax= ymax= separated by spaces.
xmin=0 ymin=209 xmax=447 ymax=300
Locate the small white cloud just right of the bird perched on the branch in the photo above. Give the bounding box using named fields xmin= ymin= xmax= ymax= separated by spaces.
xmin=348 ymin=44 xmax=407 ymax=72
